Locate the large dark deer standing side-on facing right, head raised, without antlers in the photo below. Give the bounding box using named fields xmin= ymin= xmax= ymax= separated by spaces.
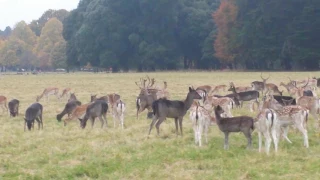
xmin=149 ymin=87 xmax=201 ymax=136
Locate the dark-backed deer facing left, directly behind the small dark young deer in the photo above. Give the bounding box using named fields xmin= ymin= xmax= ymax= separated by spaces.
xmin=228 ymin=82 xmax=259 ymax=112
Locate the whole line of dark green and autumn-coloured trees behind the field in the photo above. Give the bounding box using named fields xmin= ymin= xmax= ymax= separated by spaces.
xmin=0 ymin=0 xmax=320 ymax=71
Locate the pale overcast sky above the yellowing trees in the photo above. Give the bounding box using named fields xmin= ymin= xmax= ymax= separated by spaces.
xmin=0 ymin=0 xmax=79 ymax=30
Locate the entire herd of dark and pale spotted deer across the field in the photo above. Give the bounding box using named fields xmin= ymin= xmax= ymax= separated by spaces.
xmin=0 ymin=74 xmax=320 ymax=154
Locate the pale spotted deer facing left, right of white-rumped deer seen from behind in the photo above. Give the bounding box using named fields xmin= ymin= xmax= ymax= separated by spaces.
xmin=263 ymin=94 xmax=309 ymax=148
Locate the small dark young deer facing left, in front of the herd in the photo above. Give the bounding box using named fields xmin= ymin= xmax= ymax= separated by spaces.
xmin=214 ymin=106 xmax=254 ymax=149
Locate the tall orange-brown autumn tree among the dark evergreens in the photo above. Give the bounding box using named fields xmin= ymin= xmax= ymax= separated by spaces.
xmin=212 ymin=0 xmax=238 ymax=62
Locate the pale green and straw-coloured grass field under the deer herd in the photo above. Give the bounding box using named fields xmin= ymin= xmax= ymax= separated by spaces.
xmin=0 ymin=72 xmax=320 ymax=179
